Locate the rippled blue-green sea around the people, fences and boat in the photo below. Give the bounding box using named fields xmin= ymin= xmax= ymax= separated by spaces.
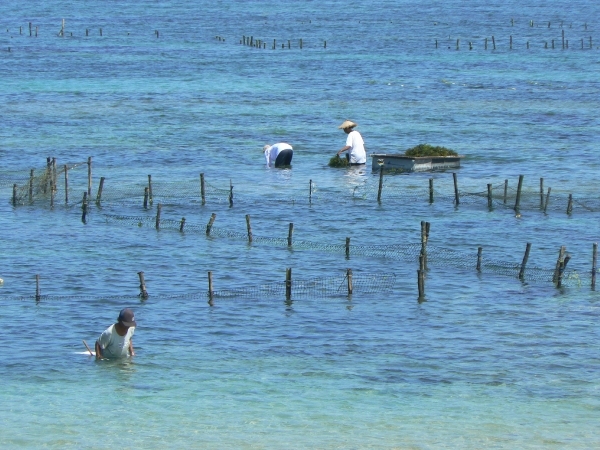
xmin=0 ymin=0 xmax=600 ymax=448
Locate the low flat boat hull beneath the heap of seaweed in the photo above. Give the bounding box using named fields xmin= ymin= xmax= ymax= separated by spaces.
xmin=371 ymin=153 xmax=464 ymax=173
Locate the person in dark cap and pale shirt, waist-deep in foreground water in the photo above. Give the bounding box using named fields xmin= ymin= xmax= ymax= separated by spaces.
xmin=96 ymin=308 xmax=136 ymax=359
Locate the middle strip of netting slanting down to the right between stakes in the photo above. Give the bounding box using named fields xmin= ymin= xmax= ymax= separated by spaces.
xmin=104 ymin=215 xmax=592 ymax=285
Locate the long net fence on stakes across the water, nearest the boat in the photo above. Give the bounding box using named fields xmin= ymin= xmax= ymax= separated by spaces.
xmin=0 ymin=162 xmax=600 ymax=213
